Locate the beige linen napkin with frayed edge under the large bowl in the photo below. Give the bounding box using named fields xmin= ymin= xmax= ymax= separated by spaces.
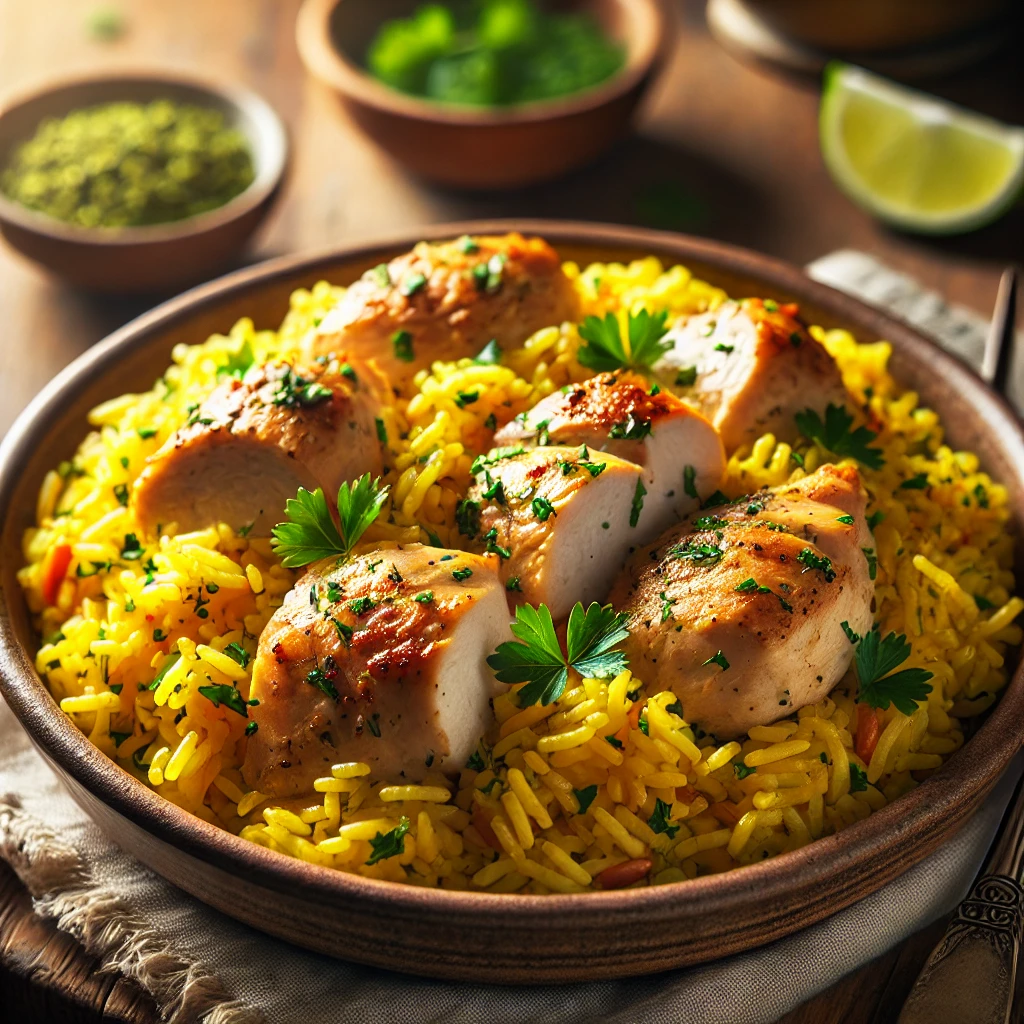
xmin=0 ymin=251 xmax=1021 ymax=1024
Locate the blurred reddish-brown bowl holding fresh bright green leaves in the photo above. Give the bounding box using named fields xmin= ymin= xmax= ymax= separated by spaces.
xmin=296 ymin=0 xmax=667 ymax=188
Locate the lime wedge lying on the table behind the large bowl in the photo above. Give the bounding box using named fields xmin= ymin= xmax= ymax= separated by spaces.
xmin=819 ymin=63 xmax=1024 ymax=234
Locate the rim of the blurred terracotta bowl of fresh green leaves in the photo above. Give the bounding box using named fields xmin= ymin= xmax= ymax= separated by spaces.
xmin=295 ymin=0 xmax=669 ymax=128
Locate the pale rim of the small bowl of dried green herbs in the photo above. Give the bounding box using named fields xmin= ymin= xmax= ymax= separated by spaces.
xmin=0 ymin=66 xmax=291 ymax=248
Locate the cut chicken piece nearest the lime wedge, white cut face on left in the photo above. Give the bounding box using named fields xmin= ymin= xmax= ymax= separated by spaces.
xmin=654 ymin=299 xmax=848 ymax=453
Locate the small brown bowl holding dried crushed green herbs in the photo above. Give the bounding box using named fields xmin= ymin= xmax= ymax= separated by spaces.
xmin=0 ymin=72 xmax=288 ymax=293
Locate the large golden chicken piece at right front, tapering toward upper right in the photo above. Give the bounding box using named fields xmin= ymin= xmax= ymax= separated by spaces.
xmin=610 ymin=465 xmax=873 ymax=739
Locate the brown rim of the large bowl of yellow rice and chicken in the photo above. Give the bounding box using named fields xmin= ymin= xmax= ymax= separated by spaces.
xmin=0 ymin=220 xmax=1024 ymax=927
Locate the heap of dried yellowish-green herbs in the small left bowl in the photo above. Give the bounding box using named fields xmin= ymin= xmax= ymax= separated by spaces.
xmin=0 ymin=99 xmax=255 ymax=228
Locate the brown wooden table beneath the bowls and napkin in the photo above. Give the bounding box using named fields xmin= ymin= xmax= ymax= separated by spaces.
xmin=0 ymin=0 xmax=1024 ymax=1024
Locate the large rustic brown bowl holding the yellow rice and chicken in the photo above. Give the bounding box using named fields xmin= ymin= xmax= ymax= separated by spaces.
xmin=0 ymin=221 xmax=1024 ymax=982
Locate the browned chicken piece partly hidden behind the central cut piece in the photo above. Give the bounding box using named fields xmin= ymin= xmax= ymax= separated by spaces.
xmin=495 ymin=371 xmax=725 ymax=544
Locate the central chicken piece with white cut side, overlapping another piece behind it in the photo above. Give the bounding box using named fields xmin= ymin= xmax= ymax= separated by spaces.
xmin=459 ymin=446 xmax=643 ymax=620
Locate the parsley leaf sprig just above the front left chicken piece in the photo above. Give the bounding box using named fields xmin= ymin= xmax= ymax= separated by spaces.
xmin=270 ymin=473 xmax=389 ymax=568
